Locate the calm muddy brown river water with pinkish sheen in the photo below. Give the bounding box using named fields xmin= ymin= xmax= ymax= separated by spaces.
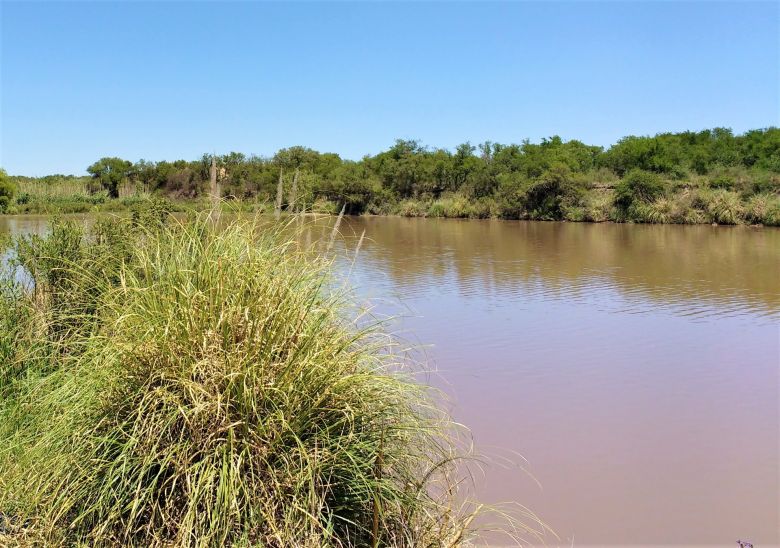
xmin=0 ymin=217 xmax=780 ymax=548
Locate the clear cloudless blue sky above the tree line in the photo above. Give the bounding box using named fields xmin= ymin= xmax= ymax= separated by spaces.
xmin=0 ymin=0 xmax=780 ymax=175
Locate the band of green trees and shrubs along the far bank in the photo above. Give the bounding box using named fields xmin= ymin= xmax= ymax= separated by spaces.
xmin=0 ymin=127 xmax=780 ymax=226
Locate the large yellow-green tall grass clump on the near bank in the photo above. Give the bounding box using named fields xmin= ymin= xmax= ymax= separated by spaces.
xmin=0 ymin=216 xmax=500 ymax=547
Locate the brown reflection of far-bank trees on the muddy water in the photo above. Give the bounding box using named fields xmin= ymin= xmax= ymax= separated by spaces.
xmin=338 ymin=218 xmax=780 ymax=319
